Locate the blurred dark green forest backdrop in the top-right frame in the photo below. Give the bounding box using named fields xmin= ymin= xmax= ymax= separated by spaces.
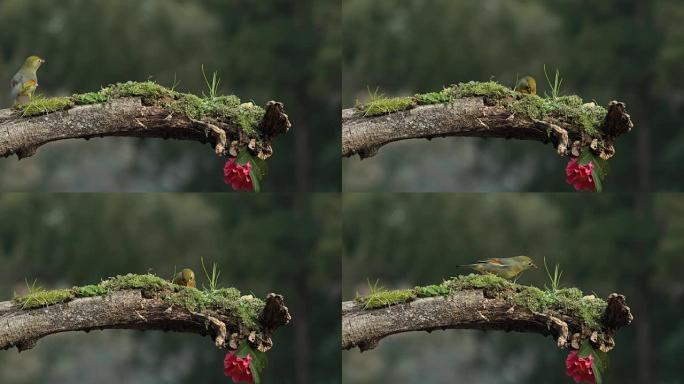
xmin=342 ymin=0 xmax=684 ymax=191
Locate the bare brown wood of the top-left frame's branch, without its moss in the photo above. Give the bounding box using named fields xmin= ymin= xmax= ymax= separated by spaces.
xmin=0 ymin=97 xmax=290 ymax=159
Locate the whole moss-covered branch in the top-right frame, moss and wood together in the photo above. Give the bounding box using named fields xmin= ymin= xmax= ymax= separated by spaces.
xmin=342 ymin=82 xmax=633 ymax=159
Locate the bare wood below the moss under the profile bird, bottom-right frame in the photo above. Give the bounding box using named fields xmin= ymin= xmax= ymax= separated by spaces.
xmin=342 ymin=289 xmax=632 ymax=351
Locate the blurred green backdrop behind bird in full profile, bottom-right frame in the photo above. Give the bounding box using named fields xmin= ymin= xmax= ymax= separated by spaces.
xmin=342 ymin=193 xmax=684 ymax=384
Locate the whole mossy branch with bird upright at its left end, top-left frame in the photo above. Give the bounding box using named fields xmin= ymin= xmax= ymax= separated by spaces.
xmin=0 ymin=82 xmax=290 ymax=159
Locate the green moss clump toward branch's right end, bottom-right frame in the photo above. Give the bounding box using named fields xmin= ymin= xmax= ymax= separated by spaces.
xmin=508 ymin=286 xmax=608 ymax=329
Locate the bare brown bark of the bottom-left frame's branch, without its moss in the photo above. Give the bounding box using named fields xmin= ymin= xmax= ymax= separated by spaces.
xmin=0 ymin=290 xmax=290 ymax=352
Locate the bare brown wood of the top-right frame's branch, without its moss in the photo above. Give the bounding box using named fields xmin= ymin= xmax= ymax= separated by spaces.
xmin=342 ymin=97 xmax=633 ymax=158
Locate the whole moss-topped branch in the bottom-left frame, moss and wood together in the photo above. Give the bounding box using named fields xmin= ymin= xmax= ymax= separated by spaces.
xmin=0 ymin=277 xmax=290 ymax=352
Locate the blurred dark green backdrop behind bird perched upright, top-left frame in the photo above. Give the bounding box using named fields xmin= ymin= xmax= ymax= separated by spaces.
xmin=0 ymin=0 xmax=341 ymax=192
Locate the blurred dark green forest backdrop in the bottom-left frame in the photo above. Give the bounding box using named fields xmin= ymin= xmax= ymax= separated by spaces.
xmin=0 ymin=194 xmax=341 ymax=384
